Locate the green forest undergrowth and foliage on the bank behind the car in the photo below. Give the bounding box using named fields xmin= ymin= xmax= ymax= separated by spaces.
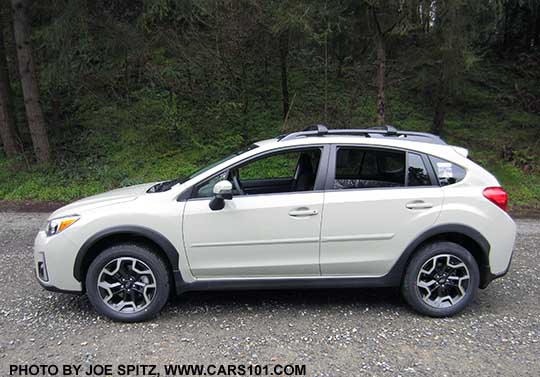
xmin=0 ymin=0 xmax=540 ymax=207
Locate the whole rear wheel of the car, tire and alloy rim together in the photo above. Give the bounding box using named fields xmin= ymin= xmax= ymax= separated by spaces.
xmin=401 ymin=241 xmax=480 ymax=317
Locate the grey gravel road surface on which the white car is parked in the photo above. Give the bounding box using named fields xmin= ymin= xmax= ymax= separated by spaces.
xmin=0 ymin=213 xmax=540 ymax=376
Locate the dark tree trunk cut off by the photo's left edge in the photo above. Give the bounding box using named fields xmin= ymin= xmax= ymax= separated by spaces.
xmin=0 ymin=11 xmax=21 ymax=158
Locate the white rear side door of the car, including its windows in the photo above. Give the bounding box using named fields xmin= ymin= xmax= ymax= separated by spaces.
xmin=320 ymin=145 xmax=443 ymax=277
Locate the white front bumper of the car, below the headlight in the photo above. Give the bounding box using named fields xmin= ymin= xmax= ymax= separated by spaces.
xmin=34 ymin=231 xmax=82 ymax=293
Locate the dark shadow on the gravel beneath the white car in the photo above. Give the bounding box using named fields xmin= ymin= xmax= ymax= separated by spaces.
xmin=38 ymin=288 xmax=504 ymax=321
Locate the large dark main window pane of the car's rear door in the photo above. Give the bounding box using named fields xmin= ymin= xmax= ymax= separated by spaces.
xmin=334 ymin=148 xmax=405 ymax=189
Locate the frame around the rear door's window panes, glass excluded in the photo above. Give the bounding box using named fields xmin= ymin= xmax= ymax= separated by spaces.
xmin=324 ymin=144 xmax=440 ymax=192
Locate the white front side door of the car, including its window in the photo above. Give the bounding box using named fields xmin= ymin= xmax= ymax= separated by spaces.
xmin=183 ymin=147 xmax=324 ymax=278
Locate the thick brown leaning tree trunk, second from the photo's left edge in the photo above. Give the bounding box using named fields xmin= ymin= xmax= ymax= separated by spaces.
xmin=11 ymin=0 xmax=50 ymax=163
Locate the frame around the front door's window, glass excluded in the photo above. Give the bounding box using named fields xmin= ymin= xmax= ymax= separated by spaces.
xmin=184 ymin=144 xmax=330 ymax=200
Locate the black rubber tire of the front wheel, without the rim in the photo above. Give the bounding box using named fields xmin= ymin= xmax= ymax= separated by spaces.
xmin=85 ymin=245 xmax=170 ymax=322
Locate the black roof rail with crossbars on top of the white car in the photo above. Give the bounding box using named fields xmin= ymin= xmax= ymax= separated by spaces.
xmin=278 ymin=124 xmax=446 ymax=145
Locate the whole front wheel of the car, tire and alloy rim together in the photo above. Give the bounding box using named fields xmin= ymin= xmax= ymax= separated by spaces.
xmin=85 ymin=244 xmax=170 ymax=322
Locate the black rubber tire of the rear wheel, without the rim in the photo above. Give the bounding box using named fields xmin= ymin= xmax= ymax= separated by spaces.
xmin=402 ymin=242 xmax=480 ymax=317
